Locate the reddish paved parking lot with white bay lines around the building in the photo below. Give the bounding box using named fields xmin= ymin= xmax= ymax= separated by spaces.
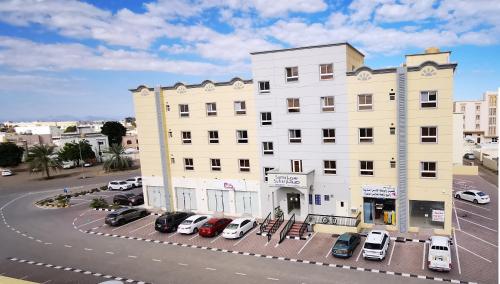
xmin=69 ymin=174 xmax=498 ymax=283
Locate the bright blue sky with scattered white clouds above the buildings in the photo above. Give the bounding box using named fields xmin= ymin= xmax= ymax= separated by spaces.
xmin=0 ymin=0 xmax=500 ymax=121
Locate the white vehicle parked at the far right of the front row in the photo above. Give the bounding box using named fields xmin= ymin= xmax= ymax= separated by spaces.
xmin=427 ymin=236 xmax=452 ymax=271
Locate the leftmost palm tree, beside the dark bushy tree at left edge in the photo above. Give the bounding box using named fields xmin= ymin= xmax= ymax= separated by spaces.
xmin=27 ymin=144 xmax=59 ymax=179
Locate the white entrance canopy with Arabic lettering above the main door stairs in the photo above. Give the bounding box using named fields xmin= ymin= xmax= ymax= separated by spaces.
xmin=267 ymin=170 xmax=314 ymax=195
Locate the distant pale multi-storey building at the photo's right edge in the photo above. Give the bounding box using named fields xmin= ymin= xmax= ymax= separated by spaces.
xmin=453 ymin=91 xmax=498 ymax=144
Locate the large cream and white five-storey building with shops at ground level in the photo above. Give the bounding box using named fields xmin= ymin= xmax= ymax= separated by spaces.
xmin=131 ymin=43 xmax=456 ymax=234
